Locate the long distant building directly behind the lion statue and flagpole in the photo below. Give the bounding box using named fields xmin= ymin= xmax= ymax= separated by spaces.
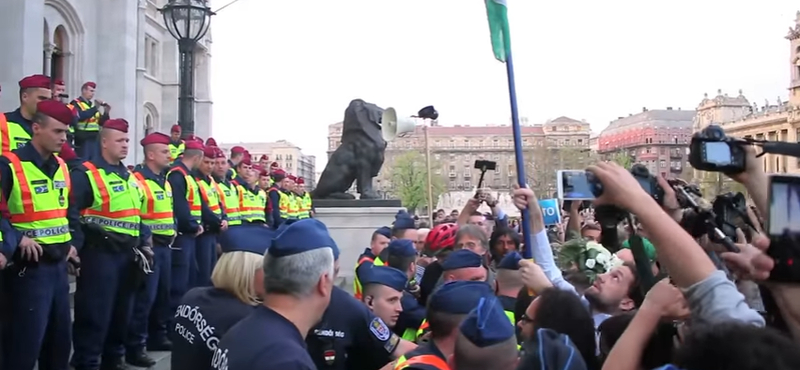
xmin=328 ymin=117 xmax=591 ymax=193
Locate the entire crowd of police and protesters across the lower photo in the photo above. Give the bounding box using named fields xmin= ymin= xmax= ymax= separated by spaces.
xmin=0 ymin=71 xmax=800 ymax=370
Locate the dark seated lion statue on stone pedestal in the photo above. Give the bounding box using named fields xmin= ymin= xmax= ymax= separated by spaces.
xmin=311 ymin=99 xmax=386 ymax=199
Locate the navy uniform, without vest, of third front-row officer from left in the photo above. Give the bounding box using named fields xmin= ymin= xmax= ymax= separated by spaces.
xmin=125 ymin=161 xmax=174 ymax=356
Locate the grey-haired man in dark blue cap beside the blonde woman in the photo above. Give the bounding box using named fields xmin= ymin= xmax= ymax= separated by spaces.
xmin=211 ymin=218 xmax=339 ymax=370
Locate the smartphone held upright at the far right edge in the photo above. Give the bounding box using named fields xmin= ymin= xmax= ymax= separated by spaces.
xmin=767 ymin=175 xmax=800 ymax=283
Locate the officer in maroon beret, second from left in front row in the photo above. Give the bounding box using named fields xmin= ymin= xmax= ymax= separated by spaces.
xmin=68 ymin=119 xmax=153 ymax=370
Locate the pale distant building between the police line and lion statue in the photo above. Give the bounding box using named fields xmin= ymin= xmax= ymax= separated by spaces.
xmin=220 ymin=140 xmax=318 ymax=191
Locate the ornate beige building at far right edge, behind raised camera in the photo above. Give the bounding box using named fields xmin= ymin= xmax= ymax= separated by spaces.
xmin=693 ymin=11 xmax=800 ymax=178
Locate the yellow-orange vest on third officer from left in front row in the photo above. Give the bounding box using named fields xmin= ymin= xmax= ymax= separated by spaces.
xmin=133 ymin=172 xmax=175 ymax=236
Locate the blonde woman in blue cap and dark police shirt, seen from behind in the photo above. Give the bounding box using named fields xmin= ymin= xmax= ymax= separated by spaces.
xmin=169 ymin=224 xmax=274 ymax=370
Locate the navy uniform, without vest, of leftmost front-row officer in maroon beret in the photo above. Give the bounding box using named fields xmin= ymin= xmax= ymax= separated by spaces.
xmin=0 ymin=142 xmax=72 ymax=370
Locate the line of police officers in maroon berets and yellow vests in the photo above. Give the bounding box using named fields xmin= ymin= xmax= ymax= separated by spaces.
xmin=0 ymin=75 xmax=314 ymax=370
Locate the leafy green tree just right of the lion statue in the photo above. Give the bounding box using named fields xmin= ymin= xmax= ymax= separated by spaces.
xmin=387 ymin=152 xmax=444 ymax=213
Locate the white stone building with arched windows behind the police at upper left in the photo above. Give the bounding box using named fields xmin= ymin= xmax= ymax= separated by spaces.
xmin=0 ymin=0 xmax=212 ymax=163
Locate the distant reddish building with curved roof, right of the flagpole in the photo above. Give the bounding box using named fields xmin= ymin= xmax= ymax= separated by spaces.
xmin=597 ymin=107 xmax=695 ymax=177
